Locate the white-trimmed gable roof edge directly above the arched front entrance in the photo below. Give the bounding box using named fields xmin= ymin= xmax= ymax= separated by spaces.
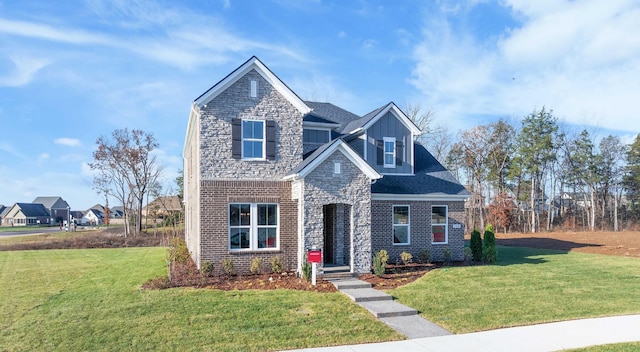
xmin=284 ymin=138 xmax=382 ymax=180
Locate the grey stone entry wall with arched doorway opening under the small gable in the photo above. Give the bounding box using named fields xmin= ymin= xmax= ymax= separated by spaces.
xmin=303 ymin=151 xmax=371 ymax=273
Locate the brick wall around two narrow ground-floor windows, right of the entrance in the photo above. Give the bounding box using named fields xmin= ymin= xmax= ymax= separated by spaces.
xmin=371 ymin=200 xmax=464 ymax=262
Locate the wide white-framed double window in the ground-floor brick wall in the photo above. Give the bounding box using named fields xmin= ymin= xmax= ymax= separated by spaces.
xmin=229 ymin=203 xmax=279 ymax=250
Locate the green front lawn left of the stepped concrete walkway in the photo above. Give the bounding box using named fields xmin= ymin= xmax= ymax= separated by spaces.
xmin=0 ymin=247 xmax=402 ymax=351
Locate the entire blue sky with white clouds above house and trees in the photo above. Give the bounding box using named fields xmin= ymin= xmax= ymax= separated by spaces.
xmin=0 ymin=0 xmax=640 ymax=210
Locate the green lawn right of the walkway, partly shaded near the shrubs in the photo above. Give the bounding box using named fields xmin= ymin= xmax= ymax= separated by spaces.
xmin=388 ymin=247 xmax=640 ymax=333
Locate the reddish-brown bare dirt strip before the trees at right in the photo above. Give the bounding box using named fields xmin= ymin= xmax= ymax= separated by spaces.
xmin=496 ymin=231 xmax=640 ymax=258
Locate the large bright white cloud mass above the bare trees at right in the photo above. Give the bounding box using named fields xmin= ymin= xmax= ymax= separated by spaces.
xmin=410 ymin=0 xmax=640 ymax=131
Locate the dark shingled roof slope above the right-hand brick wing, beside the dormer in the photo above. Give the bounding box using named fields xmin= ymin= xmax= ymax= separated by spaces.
xmin=371 ymin=142 xmax=470 ymax=200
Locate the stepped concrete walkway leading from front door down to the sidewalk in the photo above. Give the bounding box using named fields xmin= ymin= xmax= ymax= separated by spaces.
xmin=330 ymin=278 xmax=451 ymax=339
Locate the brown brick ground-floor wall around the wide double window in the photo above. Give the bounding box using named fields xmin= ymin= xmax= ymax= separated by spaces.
xmin=200 ymin=181 xmax=298 ymax=274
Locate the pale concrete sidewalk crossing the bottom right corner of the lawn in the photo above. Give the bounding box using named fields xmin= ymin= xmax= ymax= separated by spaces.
xmin=300 ymin=314 xmax=640 ymax=352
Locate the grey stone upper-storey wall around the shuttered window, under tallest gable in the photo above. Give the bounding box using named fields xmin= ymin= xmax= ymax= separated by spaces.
xmin=200 ymin=70 xmax=303 ymax=180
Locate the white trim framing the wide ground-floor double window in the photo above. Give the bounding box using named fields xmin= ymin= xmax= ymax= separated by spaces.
xmin=227 ymin=202 xmax=280 ymax=252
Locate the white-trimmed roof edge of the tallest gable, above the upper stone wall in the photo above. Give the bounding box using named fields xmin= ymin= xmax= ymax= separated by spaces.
xmin=194 ymin=56 xmax=311 ymax=114
